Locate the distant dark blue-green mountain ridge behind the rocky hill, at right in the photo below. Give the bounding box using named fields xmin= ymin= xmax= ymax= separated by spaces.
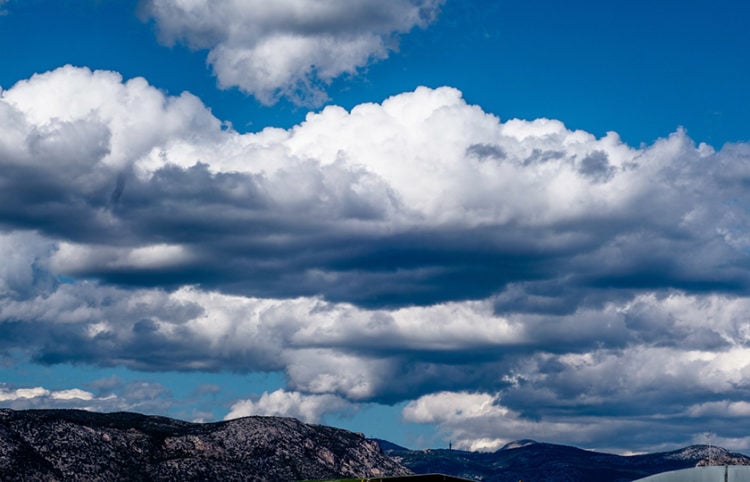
xmin=379 ymin=440 xmax=750 ymax=482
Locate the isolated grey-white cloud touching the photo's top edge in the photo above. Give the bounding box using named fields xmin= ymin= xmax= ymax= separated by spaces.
xmin=142 ymin=0 xmax=443 ymax=105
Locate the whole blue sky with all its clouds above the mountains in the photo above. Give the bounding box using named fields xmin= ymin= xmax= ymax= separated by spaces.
xmin=0 ymin=0 xmax=750 ymax=453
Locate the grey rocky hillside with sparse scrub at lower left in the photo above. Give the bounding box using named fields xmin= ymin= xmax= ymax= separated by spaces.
xmin=0 ymin=409 xmax=409 ymax=481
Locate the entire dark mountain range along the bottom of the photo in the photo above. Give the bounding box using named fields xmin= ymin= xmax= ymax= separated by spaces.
xmin=0 ymin=409 xmax=750 ymax=482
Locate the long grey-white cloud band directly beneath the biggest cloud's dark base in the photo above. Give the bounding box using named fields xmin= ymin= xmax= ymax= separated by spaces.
xmin=0 ymin=264 xmax=750 ymax=410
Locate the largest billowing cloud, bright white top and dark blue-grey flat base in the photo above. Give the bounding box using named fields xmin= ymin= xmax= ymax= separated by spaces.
xmin=0 ymin=67 xmax=748 ymax=313
